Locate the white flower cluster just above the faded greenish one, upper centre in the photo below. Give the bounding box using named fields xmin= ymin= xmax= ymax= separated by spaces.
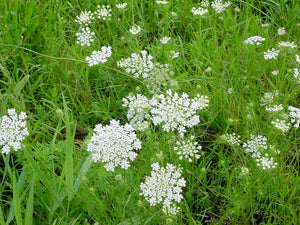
xmin=117 ymin=51 xmax=154 ymax=78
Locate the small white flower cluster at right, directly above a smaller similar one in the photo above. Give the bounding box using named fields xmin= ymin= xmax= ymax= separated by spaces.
xmin=243 ymin=135 xmax=268 ymax=158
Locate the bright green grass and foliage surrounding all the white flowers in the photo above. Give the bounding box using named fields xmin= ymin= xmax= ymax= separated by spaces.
xmin=0 ymin=0 xmax=300 ymax=225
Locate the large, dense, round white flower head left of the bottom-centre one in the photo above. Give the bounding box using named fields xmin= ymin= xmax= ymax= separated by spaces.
xmin=87 ymin=120 xmax=141 ymax=171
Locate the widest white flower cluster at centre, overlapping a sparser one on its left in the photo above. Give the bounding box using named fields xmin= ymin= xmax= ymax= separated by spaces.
xmin=150 ymin=89 xmax=209 ymax=136
